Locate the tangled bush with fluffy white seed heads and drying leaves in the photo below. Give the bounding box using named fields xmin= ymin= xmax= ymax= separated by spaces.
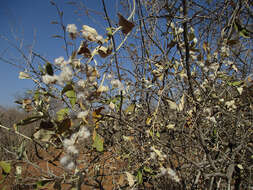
xmin=2 ymin=0 xmax=253 ymax=189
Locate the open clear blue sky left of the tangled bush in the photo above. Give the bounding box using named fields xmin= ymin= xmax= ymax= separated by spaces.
xmin=0 ymin=0 xmax=118 ymax=106
